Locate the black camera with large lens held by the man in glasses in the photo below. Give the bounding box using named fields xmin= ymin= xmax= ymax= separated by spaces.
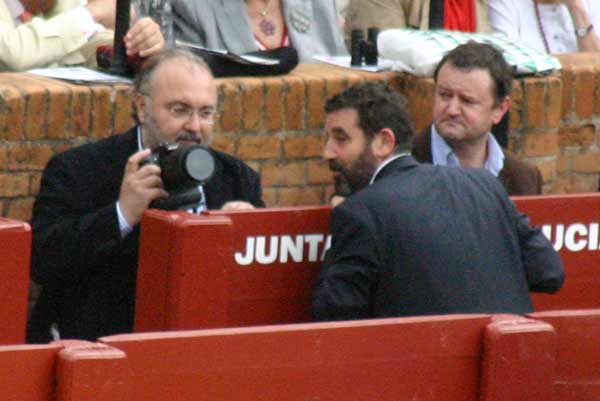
xmin=140 ymin=142 xmax=215 ymax=210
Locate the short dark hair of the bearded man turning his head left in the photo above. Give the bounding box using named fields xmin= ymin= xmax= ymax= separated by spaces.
xmin=325 ymin=82 xmax=414 ymax=152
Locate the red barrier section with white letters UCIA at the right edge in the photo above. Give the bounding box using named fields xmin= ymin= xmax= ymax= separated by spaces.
xmin=514 ymin=194 xmax=600 ymax=311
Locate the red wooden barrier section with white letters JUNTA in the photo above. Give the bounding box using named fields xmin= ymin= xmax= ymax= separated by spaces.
xmin=135 ymin=207 xmax=330 ymax=332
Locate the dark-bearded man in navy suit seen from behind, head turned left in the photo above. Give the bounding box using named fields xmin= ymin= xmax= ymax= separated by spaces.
xmin=313 ymin=83 xmax=564 ymax=320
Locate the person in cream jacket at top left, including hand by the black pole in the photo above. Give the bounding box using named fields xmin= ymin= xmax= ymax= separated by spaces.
xmin=0 ymin=0 xmax=164 ymax=71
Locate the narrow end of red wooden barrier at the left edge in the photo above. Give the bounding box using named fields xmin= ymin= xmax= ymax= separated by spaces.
xmin=0 ymin=218 xmax=31 ymax=344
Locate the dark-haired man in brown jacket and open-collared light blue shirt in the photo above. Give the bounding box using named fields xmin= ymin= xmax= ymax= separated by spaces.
xmin=412 ymin=42 xmax=542 ymax=195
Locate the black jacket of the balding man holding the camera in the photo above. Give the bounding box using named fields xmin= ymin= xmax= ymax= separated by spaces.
xmin=28 ymin=129 xmax=264 ymax=342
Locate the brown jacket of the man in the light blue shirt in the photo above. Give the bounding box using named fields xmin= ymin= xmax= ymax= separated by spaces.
xmin=412 ymin=127 xmax=543 ymax=196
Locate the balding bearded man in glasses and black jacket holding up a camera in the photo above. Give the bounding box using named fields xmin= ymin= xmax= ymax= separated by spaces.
xmin=28 ymin=50 xmax=264 ymax=342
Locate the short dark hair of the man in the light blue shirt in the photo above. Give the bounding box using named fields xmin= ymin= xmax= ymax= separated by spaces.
xmin=433 ymin=42 xmax=513 ymax=104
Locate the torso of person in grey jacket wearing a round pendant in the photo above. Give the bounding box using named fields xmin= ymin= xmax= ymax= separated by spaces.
xmin=173 ymin=0 xmax=346 ymax=62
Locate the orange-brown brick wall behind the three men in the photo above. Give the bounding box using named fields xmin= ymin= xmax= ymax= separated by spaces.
xmin=0 ymin=55 xmax=600 ymax=220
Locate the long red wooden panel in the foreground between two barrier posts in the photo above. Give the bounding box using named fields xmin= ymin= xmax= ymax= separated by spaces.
xmin=110 ymin=315 xmax=494 ymax=401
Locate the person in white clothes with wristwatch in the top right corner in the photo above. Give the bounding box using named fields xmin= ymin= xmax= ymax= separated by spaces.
xmin=489 ymin=0 xmax=600 ymax=53
